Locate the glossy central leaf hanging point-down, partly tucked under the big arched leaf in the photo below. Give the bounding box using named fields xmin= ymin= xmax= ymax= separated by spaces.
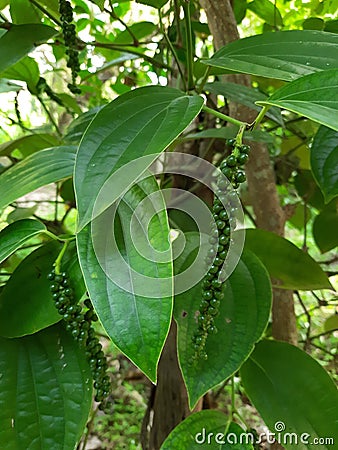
xmin=77 ymin=177 xmax=172 ymax=382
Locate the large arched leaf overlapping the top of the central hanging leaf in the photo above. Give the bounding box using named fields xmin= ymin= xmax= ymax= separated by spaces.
xmin=74 ymin=86 xmax=203 ymax=229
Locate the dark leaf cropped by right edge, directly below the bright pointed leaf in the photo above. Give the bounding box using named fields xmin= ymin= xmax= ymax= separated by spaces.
xmin=311 ymin=126 xmax=338 ymax=202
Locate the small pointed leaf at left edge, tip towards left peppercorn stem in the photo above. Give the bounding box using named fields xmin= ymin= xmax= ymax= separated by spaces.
xmin=0 ymin=219 xmax=46 ymax=263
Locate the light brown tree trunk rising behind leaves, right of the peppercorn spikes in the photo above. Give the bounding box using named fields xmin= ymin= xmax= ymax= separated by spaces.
xmin=201 ymin=0 xmax=297 ymax=344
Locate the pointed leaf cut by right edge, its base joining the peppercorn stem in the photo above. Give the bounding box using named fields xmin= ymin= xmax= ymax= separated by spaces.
xmin=257 ymin=69 xmax=338 ymax=131
